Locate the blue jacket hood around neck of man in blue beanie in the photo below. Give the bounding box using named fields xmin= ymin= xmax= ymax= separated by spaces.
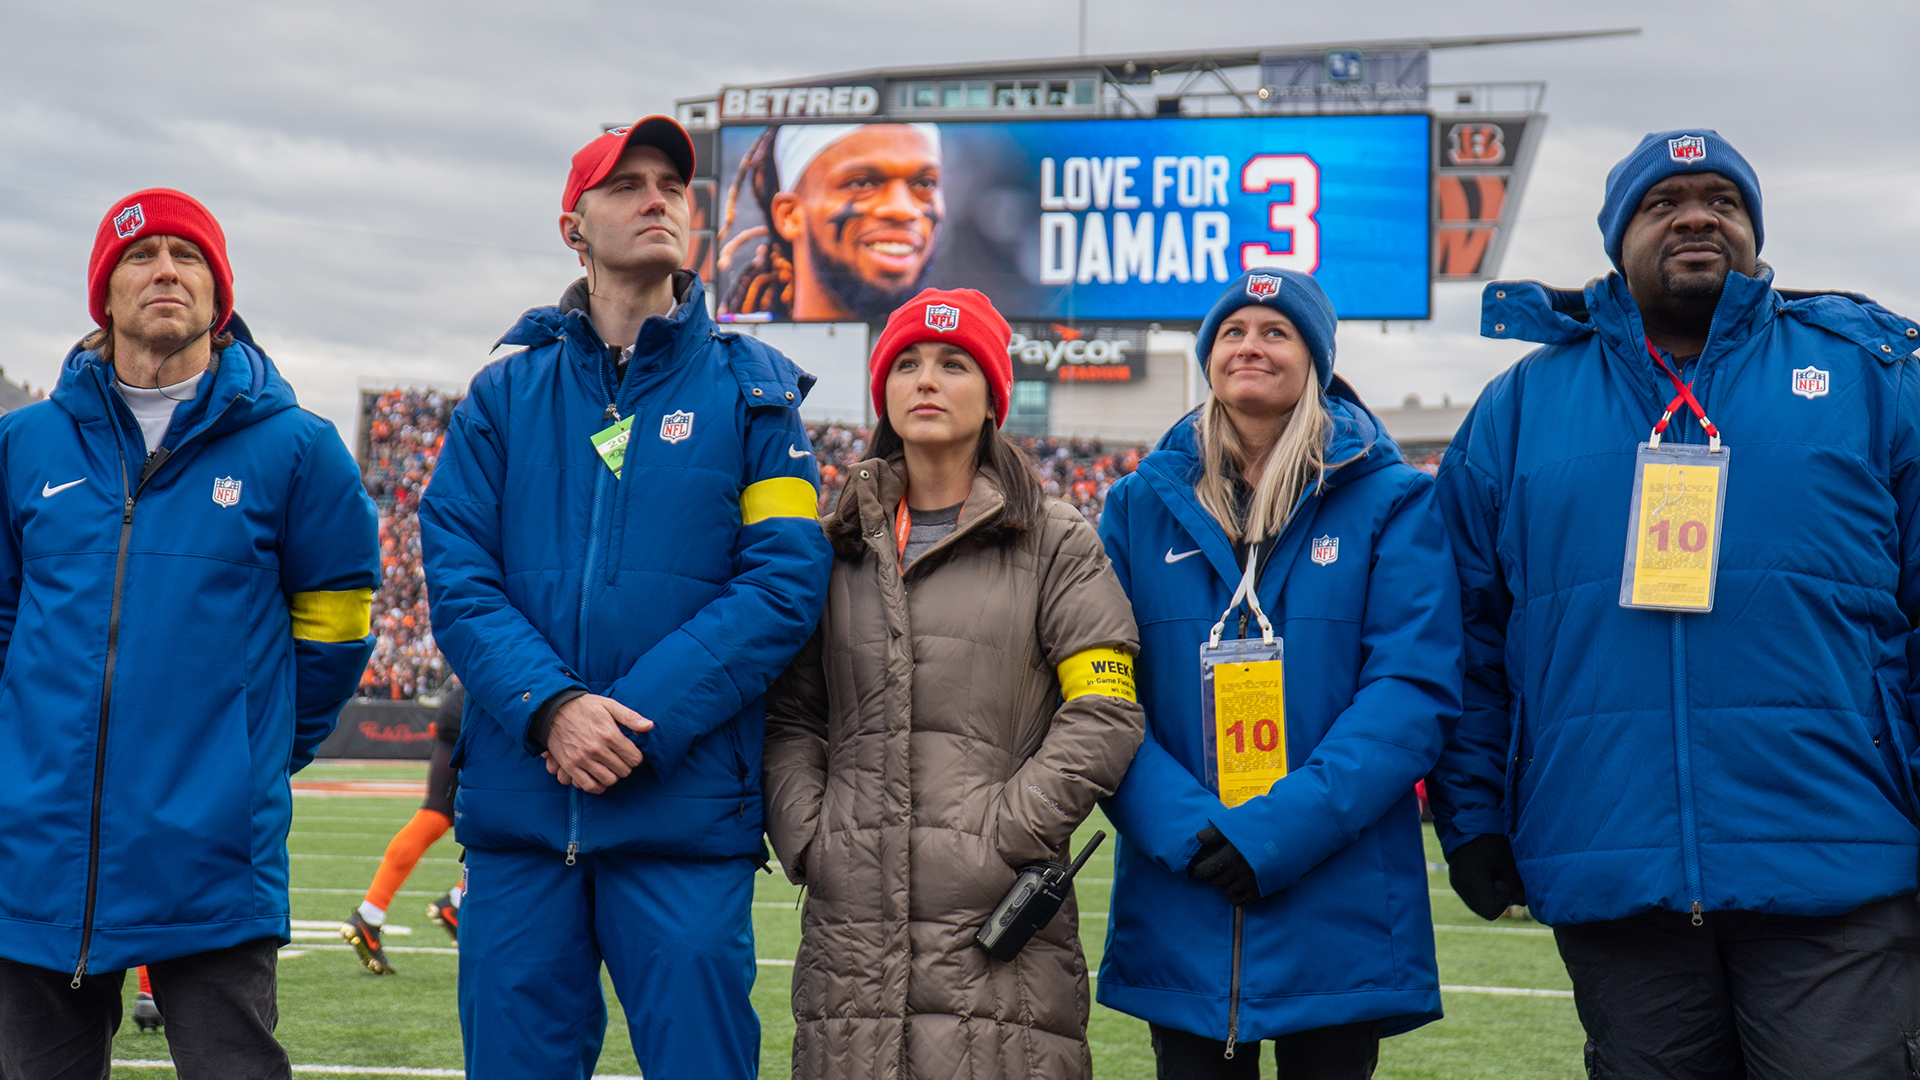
xmin=1480 ymin=261 xmax=1920 ymax=361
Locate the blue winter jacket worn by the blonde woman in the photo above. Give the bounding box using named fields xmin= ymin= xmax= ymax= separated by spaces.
xmin=1100 ymin=380 xmax=1461 ymax=1040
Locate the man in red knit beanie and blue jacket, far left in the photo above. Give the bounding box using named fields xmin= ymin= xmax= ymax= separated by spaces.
xmin=0 ymin=188 xmax=380 ymax=1080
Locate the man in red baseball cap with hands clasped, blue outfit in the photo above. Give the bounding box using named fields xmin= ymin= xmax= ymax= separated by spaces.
xmin=420 ymin=117 xmax=833 ymax=1080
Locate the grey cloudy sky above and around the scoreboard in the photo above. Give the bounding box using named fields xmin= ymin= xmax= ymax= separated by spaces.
xmin=0 ymin=0 xmax=1920 ymax=434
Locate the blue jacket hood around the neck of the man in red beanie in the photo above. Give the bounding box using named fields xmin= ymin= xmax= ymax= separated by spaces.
xmin=50 ymin=315 xmax=300 ymax=436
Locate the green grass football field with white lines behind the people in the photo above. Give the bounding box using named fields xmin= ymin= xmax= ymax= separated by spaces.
xmin=113 ymin=763 xmax=1584 ymax=1080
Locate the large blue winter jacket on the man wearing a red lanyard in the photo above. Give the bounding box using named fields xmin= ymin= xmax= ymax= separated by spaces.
xmin=1428 ymin=271 xmax=1920 ymax=924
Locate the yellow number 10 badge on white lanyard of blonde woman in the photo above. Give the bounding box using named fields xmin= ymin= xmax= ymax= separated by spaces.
xmin=1200 ymin=552 xmax=1286 ymax=807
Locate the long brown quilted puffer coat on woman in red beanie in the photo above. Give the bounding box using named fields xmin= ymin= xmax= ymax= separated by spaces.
xmin=766 ymin=459 xmax=1144 ymax=1080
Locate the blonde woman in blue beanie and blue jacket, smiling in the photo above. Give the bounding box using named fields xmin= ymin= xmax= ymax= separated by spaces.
xmin=1100 ymin=271 xmax=1461 ymax=1080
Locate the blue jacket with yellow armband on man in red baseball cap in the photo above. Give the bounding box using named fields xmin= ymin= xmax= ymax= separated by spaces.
xmin=420 ymin=275 xmax=833 ymax=857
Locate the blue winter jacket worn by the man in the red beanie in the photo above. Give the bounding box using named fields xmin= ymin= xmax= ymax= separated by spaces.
xmin=0 ymin=319 xmax=380 ymax=972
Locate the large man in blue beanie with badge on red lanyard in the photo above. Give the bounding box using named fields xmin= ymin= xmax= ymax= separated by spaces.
xmin=1427 ymin=129 xmax=1920 ymax=1080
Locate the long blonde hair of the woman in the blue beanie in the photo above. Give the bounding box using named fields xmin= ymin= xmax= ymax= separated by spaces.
xmin=1194 ymin=367 xmax=1332 ymax=544
